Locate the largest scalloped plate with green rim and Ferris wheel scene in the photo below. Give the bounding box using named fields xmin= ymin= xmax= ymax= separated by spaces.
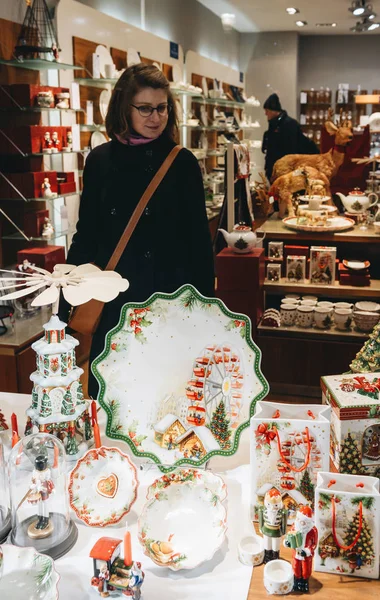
xmin=92 ymin=285 xmax=269 ymax=472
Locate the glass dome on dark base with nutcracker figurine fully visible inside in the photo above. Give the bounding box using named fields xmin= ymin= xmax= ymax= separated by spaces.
xmin=8 ymin=433 xmax=78 ymax=559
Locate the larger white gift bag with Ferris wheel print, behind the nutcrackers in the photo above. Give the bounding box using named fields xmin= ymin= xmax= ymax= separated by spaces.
xmin=250 ymin=402 xmax=331 ymax=523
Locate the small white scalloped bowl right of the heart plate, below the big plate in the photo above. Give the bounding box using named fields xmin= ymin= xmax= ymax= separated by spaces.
xmin=138 ymin=485 xmax=227 ymax=571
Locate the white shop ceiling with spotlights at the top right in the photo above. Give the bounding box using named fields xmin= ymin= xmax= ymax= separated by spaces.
xmin=198 ymin=0 xmax=380 ymax=35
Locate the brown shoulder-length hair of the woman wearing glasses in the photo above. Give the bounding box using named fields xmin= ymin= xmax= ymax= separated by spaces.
xmin=106 ymin=63 xmax=178 ymax=141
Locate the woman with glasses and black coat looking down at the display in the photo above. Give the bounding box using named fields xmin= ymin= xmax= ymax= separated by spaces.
xmin=67 ymin=64 xmax=214 ymax=398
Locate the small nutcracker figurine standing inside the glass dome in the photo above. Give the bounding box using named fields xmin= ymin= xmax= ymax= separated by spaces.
xmin=25 ymin=454 xmax=54 ymax=539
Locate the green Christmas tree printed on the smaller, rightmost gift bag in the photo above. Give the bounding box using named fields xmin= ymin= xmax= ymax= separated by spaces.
xmin=344 ymin=497 xmax=375 ymax=565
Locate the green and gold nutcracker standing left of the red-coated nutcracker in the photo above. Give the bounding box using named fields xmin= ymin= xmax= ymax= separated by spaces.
xmin=257 ymin=488 xmax=288 ymax=563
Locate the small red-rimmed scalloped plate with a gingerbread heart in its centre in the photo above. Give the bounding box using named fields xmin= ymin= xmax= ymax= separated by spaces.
xmin=69 ymin=446 xmax=138 ymax=527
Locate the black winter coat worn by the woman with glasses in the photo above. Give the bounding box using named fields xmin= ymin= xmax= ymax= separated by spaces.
xmin=67 ymin=135 xmax=214 ymax=398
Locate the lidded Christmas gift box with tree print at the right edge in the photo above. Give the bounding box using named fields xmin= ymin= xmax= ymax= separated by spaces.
xmin=321 ymin=372 xmax=380 ymax=476
